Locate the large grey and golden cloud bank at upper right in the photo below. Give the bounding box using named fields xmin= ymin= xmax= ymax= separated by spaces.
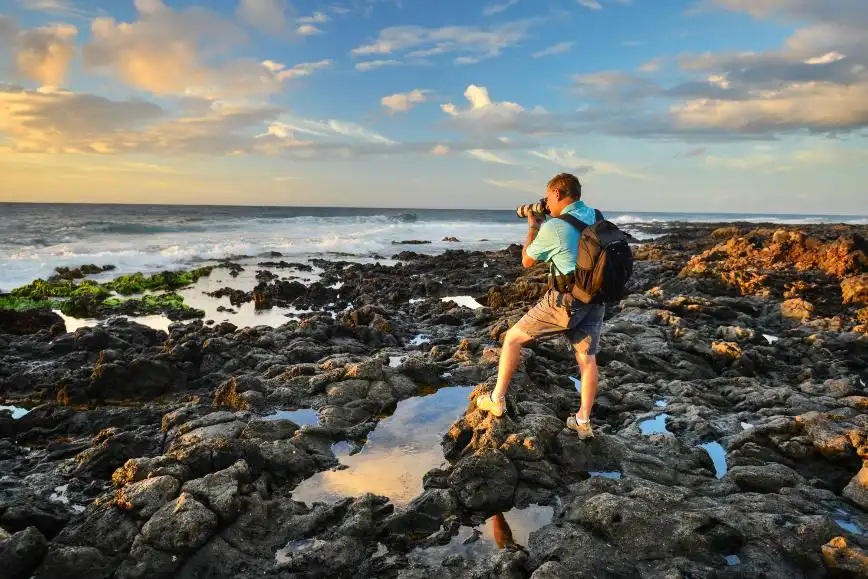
xmin=560 ymin=0 xmax=868 ymax=140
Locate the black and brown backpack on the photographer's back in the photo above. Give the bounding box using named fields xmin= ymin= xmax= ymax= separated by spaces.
xmin=558 ymin=209 xmax=633 ymax=304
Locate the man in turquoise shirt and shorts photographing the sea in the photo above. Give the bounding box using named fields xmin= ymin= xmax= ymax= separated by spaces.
xmin=476 ymin=173 xmax=605 ymax=440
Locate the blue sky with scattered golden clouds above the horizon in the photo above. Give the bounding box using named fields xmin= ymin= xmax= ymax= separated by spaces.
xmin=0 ymin=0 xmax=868 ymax=215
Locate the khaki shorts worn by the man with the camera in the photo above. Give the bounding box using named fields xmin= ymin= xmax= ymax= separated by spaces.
xmin=516 ymin=290 xmax=606 ymax=356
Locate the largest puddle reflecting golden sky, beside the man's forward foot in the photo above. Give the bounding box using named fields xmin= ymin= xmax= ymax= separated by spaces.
xmin=292 ymin=386 xmax=473 ymax=506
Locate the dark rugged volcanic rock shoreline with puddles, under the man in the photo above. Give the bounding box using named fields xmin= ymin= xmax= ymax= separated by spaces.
xmin=0 ymin=223 xmax=868 ymax=579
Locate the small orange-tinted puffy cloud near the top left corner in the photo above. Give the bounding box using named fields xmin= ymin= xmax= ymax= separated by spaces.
xmin=0 ymin=16 xmax=78 ymax=86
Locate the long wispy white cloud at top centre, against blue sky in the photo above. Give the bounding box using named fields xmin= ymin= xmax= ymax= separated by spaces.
xmin=350 ymin=20 xmax=536 ymax=64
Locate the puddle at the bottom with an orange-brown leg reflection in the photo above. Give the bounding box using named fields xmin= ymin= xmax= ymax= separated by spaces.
xmin=407 ymin=505 xmax=554 ymax=567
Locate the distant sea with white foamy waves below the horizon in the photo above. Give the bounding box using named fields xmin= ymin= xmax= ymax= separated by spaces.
xmin=0 ymin=203 xmax=868 ymax=291
